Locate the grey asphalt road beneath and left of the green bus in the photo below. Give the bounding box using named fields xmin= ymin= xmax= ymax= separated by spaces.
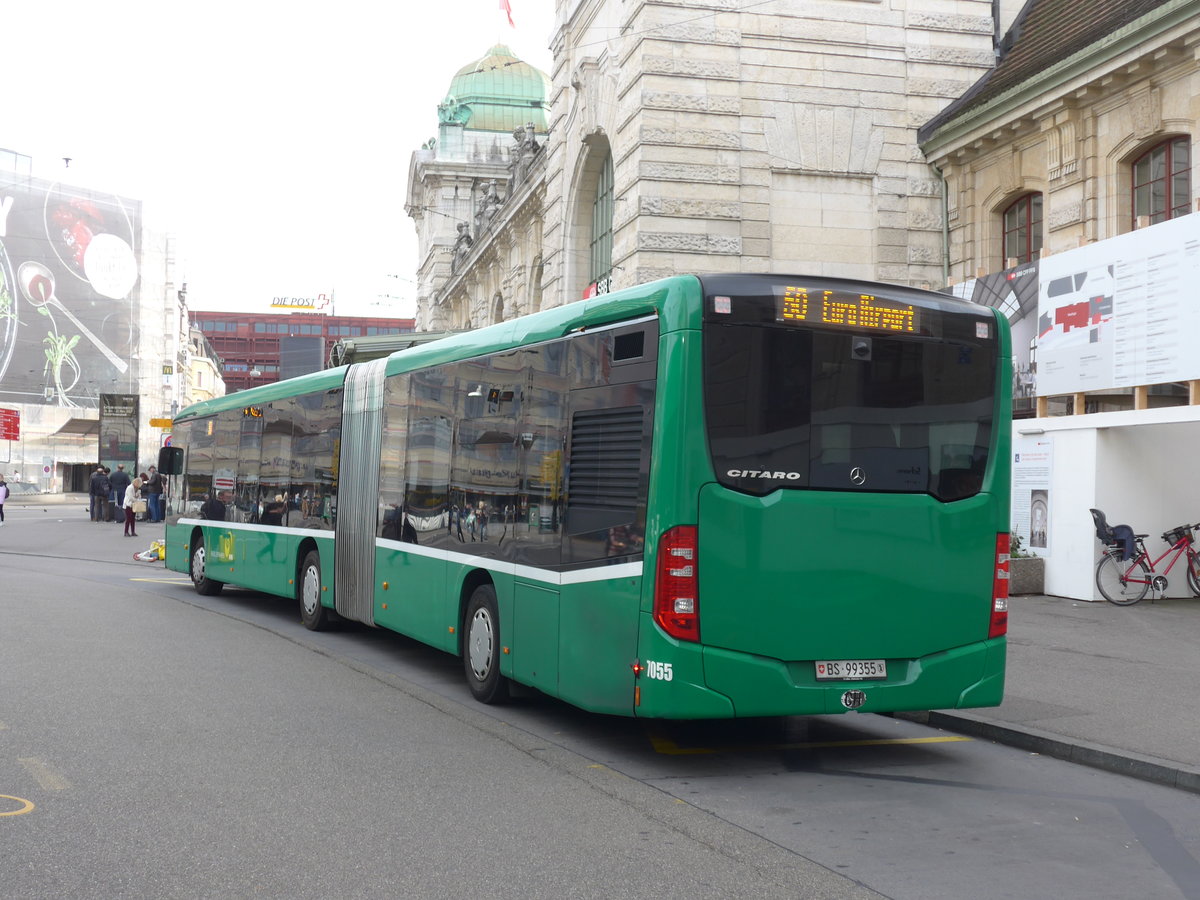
xmin=7 ymin=509 xmax=1200 ymax=900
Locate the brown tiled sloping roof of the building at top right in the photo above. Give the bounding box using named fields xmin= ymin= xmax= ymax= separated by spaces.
xmin=918 ymin=0 xmax=1171 ymax=140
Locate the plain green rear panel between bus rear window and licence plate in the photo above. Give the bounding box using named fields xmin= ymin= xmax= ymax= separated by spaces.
xmin=700 ymin=485 xmax=1007 ymax=660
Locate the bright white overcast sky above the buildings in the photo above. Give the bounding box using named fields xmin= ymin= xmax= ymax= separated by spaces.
xmin=0 ymin=0 xmax=554 ymax=316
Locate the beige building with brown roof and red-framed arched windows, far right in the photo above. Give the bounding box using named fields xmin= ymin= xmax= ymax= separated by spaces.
xmin=919 ymin=0 xmax=1200 ymax=415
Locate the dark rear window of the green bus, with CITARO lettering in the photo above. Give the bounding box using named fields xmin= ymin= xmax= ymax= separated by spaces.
xmin=704 ymin=321 xmax=997 ymax=500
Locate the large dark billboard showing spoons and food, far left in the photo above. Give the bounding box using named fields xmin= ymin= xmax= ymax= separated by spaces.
xmin=0 ymin=172 xmax=142 ymax=408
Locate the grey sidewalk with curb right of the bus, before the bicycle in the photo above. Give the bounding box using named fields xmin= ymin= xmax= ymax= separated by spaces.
xmin=8 ymin=493 xmax=1200 ymax=793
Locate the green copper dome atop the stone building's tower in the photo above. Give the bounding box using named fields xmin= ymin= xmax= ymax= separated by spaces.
xmin=442 ymin=43 xmax=550 ymax=134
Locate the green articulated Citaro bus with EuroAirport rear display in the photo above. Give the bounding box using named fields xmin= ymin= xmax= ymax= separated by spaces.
xmin=167 ymin=275 xmax=1012 ymax=719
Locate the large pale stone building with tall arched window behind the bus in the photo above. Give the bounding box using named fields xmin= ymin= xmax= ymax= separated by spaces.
xmin=409 ymin=0 xmax=996 ymax=329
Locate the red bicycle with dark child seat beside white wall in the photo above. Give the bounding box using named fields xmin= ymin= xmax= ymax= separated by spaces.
xmin=1091 ymin=509 xmax=1200 ymax=606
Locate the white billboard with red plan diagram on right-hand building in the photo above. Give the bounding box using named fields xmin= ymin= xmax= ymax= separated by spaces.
xmin=1037 ymin=214 xmax=1200 ymax=395
